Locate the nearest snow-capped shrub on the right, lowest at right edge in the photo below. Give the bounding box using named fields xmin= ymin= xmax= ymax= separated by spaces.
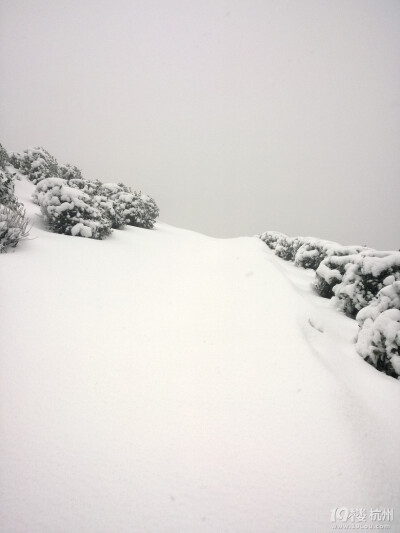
xmin=356 ymin=281 xmax=400 ymax=378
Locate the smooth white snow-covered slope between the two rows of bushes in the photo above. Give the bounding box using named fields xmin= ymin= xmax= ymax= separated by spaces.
xmin=0 ymin=182 xmax=400 ymax=533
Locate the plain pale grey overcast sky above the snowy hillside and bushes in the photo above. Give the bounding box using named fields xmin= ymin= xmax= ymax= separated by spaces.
xmin=0 ymin=0 xmax=400 ymax=249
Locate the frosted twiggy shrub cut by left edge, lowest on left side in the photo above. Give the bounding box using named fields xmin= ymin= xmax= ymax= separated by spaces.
xmin=0 ymin=205 xmax=29 ymax=253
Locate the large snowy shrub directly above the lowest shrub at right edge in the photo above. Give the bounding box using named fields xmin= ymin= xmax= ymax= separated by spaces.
xmin=333 ymin=250 xmax=400 ymax=317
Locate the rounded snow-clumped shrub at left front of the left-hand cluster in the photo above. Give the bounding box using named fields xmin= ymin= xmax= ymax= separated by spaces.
xmin=36 ymin=178 xmax=112 ymax=239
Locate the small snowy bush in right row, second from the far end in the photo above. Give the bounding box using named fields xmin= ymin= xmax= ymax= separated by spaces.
xmin=294 ymin=237 xmax=363 ymax=270
